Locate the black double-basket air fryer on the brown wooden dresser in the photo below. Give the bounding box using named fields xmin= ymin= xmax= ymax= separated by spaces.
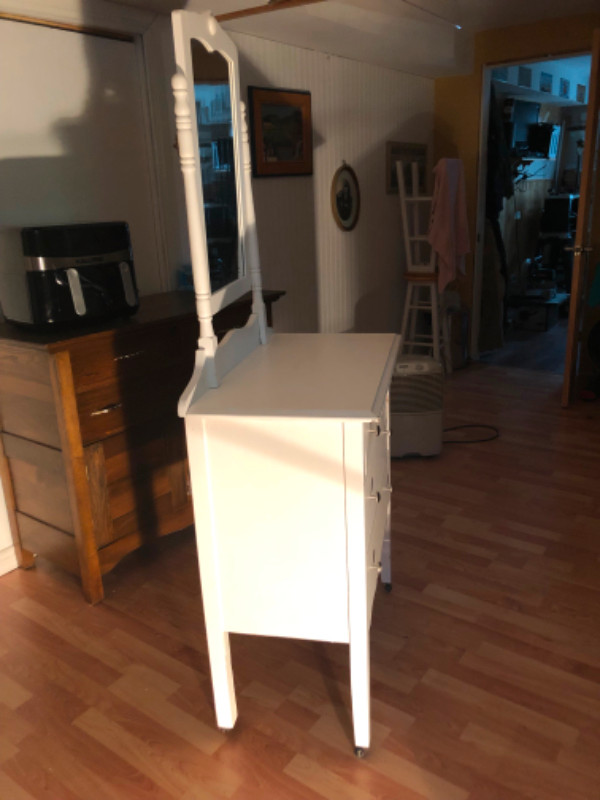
xmin=0 ymin=222 xmax=139 ymax=327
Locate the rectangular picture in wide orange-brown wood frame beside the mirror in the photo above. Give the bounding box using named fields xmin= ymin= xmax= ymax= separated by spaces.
xmin=248 ymin=86 xmax=312 ymax=177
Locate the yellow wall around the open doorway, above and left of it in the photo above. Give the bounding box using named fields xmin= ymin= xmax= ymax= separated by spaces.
xmin=434 ymin=14 xmax=600 ymax=307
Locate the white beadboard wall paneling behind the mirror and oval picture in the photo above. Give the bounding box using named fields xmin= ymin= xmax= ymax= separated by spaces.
xmin=232 ymin=33 xmax=433 ymax=332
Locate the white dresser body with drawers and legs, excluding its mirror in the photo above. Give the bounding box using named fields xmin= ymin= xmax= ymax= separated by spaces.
xmin=185 ymin=334 xmax=399 ymax=754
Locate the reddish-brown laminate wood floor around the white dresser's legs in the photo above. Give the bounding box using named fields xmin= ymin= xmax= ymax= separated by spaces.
xmin=0 ymin=366 xmax=600 ymax=800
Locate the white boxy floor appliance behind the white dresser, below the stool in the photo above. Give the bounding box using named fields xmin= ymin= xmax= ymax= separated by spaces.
xmin=390 ymin=355 xmax=444 ymax=458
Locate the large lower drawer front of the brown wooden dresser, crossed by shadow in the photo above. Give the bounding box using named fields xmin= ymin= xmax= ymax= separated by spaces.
xmin=98 ymin=419 xmax=193 ymax=546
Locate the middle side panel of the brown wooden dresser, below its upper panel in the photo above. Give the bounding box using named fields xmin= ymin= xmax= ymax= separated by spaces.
xmin=2 ymin=434 xmax=74 ymax=533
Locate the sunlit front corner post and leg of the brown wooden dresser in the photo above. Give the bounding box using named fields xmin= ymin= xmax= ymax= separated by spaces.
xmin=50 ymin=351 xmax=104 ymax=603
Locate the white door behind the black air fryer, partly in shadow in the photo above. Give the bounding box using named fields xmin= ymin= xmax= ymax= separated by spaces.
xmin=0 ymin=20 xmax=168 ymax=294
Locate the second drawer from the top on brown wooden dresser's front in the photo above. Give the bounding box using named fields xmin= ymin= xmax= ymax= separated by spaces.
xmin=77 ymin=361 xmax=192 ymax=444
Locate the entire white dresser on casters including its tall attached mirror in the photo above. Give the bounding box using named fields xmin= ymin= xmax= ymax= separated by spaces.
xmin=173 ymin=11 xmax=400 ymax=755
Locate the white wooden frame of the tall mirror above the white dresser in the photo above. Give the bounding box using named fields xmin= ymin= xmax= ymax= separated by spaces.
xmin=172 ymin=11 xmax=255 ymax=316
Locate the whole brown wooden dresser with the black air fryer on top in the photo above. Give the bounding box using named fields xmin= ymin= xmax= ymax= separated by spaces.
xmin=0 ymin=291 xmax=283 ymax=603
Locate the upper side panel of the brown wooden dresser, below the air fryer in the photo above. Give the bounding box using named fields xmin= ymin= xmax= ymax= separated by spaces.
xmin=0 ymin=344 xmax=60 ymax=447
